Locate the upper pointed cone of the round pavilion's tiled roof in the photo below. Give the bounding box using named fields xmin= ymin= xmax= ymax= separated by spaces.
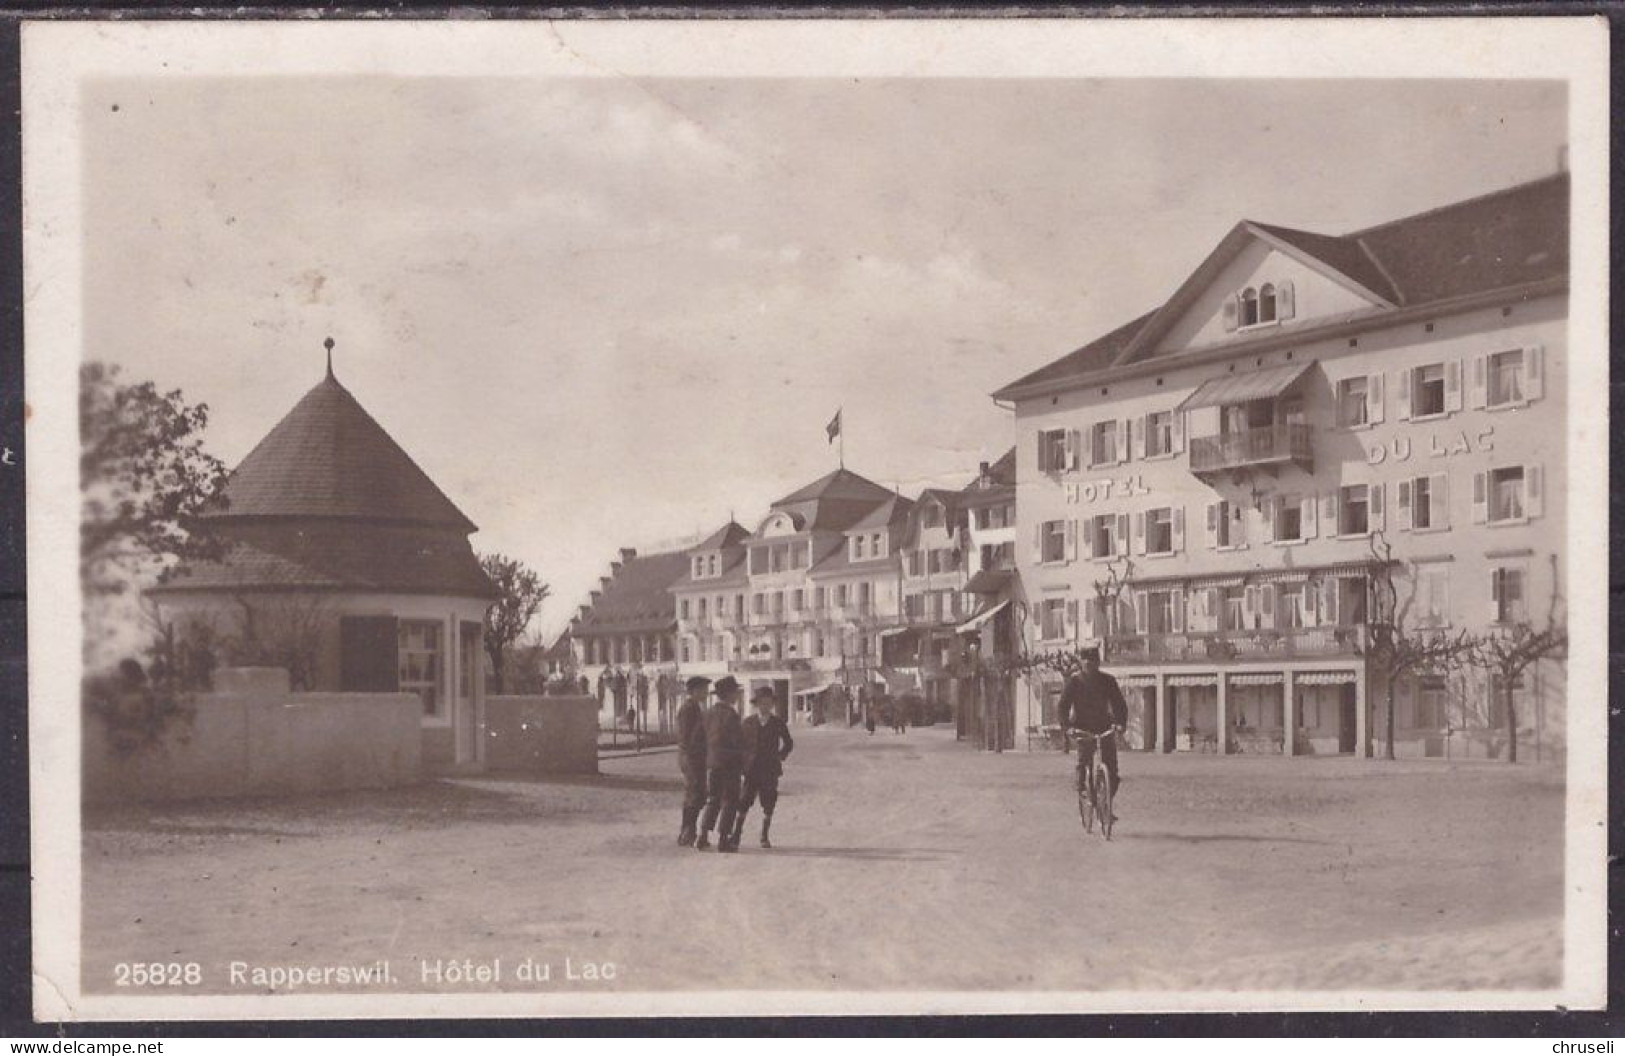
xmin=213 ymin=370 xmax=475 ymax=534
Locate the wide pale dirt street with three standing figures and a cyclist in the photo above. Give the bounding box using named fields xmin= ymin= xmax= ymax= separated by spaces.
xmin=85 ymin=728 xmax=1563 ymax=993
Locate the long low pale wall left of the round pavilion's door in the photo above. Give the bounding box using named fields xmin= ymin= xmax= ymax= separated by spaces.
xmin=81 ymin=687 xmax=423 ymax=803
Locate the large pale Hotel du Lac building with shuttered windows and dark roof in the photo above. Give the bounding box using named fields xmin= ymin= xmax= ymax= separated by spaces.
xmin=995 ymin=175 xmax=1566 ymax=757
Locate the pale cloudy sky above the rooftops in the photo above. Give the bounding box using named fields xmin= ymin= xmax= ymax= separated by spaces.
xmin=81 ymin=76 xmax=1567 ymax=637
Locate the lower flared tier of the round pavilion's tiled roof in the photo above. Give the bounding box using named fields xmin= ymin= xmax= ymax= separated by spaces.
xmin=154 ymin=518 xmax=497 ymax=598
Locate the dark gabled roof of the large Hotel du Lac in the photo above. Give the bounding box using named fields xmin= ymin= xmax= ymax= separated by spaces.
xmin=993 ymin=172 xmax=1568 ymax=400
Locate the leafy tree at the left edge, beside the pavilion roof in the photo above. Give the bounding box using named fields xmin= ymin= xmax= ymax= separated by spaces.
xmin=80 ymin=362 xmax=228 ymax=593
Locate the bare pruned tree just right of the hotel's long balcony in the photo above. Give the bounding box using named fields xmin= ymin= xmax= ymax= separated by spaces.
xmin=1365 ymin=531 xmax=1474 ymax=759
